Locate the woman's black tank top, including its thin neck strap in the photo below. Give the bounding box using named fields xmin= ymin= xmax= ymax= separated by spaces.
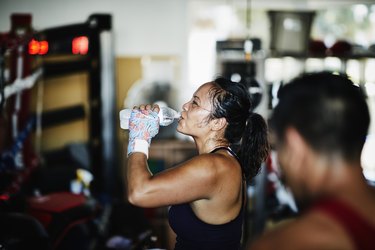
xmin=168 ymin=147 xmax=245 ymax=250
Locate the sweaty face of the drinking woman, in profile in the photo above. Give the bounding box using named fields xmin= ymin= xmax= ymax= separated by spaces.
xmin=177 ymin=82 xmax=213 ymax=137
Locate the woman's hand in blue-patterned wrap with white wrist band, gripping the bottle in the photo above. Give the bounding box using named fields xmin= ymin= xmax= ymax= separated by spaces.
xmin=128 ymin=104 xmax=160 ymax=156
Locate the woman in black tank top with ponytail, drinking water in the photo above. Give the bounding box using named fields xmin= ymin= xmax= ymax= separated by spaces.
xmin=127 ymin=78 xmax=269 ymax=250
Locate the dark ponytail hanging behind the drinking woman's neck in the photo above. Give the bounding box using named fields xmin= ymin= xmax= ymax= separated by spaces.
xmin=238 ymin=113 xmax=270 ymax=180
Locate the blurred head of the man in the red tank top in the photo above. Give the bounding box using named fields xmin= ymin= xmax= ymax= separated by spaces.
xmin=270 ymin=72 xmax=370 ymax=203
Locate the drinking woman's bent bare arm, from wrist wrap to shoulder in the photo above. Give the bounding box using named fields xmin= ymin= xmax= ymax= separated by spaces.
xmin=127 ymin=153 xmax=220 ymax=207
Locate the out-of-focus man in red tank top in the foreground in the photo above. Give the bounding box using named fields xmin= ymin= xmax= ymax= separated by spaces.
xmin=248 ymin=72 xmax=375 ymax=250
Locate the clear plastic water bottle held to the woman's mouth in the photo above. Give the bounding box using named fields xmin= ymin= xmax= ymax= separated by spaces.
xmin=120 ymin=107 xmax=181 ymax=129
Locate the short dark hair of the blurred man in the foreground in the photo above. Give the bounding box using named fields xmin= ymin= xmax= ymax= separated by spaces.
xmin=270 ymin=72 xmax=370 ymax=161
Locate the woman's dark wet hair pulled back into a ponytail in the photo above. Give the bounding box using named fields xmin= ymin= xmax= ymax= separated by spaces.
xmin=210 ymin=77 xmax=269 ymax=179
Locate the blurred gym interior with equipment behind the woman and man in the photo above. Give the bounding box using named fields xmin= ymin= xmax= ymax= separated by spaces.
xmin=0 ymin=0 xmax=375 ymax=249
